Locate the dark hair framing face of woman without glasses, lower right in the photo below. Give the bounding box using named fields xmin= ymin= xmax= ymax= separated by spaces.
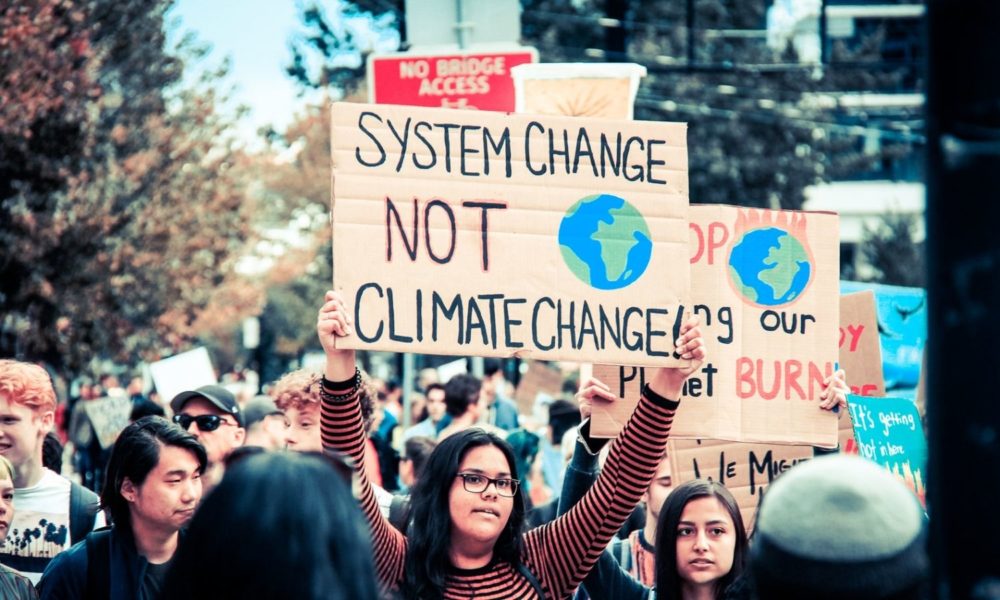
xmin=656 ymin=479 xmax=749 ymax=598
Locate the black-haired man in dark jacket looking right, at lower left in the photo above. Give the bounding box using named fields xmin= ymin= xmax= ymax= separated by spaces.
xmin=38 ymin=417 xmax=208 ymax=600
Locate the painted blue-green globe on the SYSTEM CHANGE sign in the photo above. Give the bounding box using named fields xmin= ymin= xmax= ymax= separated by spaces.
xmin=559 ymin=194 xmax=653 ymax=290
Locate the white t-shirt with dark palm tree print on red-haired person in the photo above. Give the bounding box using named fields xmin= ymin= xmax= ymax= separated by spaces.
xmin=0 ymin=469 xmax=105 ymax=585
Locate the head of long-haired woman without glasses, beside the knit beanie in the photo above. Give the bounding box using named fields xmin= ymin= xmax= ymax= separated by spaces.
xmin=656 ymin=479 xmax=748 ymax=600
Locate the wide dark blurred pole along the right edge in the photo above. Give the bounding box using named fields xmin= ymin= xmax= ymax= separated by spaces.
xmin=926 ymin=0 xmax=1000 ymax=600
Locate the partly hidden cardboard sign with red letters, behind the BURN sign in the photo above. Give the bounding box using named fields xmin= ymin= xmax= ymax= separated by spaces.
xmin=838 ymin=290 xmax=885 ymax=454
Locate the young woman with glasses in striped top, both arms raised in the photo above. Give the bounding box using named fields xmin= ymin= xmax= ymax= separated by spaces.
xmin=317 ymin=292 xmax=705 ymax=600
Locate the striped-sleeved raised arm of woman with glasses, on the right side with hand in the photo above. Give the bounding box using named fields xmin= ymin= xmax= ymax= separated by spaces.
xmin=525 ymin=319 xmax=705 ymax=598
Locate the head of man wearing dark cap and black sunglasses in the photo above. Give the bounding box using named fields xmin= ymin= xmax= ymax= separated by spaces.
xmin=170 ymin=385 xmax=246 ymax=492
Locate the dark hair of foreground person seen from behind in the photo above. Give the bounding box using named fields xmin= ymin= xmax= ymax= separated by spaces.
xmin=163 ymin=452 xmax=378 ymax=600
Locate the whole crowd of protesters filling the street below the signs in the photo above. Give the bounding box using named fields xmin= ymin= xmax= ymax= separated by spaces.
xmin=0 ymin=292 xmax=928 ymax=600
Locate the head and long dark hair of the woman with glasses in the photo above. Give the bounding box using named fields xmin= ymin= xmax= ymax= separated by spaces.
xmin=405 ymin=427 xmax=525 ymax=598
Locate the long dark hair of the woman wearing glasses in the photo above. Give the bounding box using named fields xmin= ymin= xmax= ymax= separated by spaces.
xmin=403 ymin=427 xmax=525 ymax=600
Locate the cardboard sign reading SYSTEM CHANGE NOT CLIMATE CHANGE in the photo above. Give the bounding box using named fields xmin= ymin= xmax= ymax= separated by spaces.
xmin=332 ymin=103 xmax=688 ymax=365
